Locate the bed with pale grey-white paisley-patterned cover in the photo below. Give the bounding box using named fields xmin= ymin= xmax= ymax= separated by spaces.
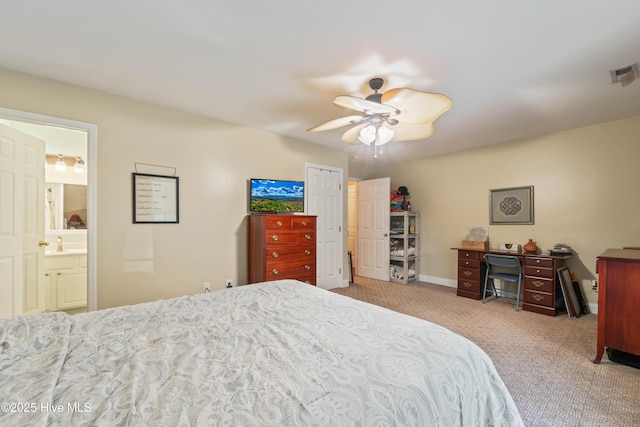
xmin=0 ymin=280 xmax=522 ymax=426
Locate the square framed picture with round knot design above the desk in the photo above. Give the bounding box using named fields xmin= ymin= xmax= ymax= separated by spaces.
xmin=489 ymin=185 xmax=533 ymax=224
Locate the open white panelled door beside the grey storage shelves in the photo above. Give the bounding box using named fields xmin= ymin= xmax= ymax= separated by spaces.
xmin=357 ymin=178 xmax=391 ymax=280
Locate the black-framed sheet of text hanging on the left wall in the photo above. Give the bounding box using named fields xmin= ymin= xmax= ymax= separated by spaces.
xmin=132 ymin=172 xmax=180 ymax=224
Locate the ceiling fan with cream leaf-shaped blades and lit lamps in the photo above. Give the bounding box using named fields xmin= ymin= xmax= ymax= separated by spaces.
xmin=308 ymin=77 xmax=451 ymax=145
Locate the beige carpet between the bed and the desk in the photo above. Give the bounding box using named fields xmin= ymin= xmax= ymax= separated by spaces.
xmin=333 ymin=277 xmax=640 ymax=427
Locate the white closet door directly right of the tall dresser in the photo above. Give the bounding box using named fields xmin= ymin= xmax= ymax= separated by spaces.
xmin=305 ymin=165 xmax=344 ymax=289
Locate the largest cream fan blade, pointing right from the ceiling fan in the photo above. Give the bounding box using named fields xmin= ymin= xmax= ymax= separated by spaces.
xmin=382 ymin=88 xmax=451 ymax=123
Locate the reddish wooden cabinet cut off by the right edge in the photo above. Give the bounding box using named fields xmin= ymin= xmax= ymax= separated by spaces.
xmin=594 ymin=249 xmax=640 ymax=363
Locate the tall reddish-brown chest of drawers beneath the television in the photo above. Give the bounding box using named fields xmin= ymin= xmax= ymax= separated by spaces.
xmin=249 ymin=214 xmax=316 ymax=285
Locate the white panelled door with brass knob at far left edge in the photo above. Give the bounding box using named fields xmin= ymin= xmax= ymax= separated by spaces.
xmin=0 ymin=125 xmax=45 ymax=317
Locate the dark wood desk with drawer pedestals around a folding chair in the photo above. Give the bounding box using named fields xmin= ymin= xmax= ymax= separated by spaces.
xmin=451 ymin=248 xmax=571 ymax=316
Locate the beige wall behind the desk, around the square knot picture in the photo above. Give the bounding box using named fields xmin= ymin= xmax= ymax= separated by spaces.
xmin=358 ymin=117 xmax=640 ymax=306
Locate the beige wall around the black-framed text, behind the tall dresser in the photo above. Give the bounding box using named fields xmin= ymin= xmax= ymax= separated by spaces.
xmin=0 ymin=69 xmax=348 ymax=308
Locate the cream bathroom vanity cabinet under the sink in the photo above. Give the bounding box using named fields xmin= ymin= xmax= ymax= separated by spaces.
xmin=44 ymin=254 xmax=87 ymax=311
